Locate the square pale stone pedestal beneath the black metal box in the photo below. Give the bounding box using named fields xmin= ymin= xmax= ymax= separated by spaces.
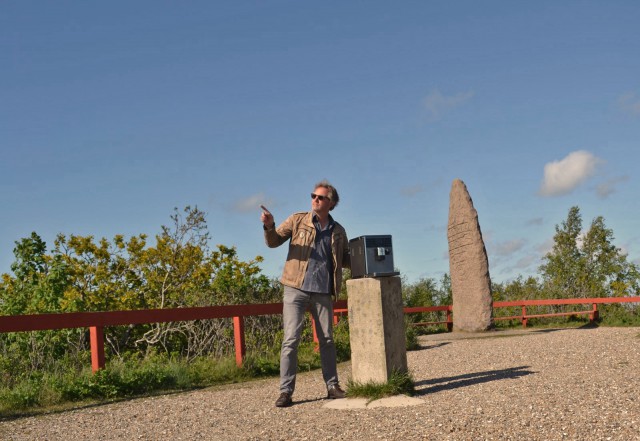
xmin=347 ymin=277 xmax=407 ymax=384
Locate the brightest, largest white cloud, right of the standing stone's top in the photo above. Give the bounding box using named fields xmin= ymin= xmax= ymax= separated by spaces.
xmin=539 ymin=150 xmax=604 ymax=196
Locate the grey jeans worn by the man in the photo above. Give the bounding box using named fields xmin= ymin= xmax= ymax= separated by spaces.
xmin=280 ymin=286 xmax=338 ymax=394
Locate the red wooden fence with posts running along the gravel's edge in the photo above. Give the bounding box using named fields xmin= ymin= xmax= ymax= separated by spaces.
xmin=0 ymin=297 xmax=640 ymax=372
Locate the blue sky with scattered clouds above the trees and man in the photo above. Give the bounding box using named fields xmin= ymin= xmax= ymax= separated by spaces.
xmin=0 ymin=0 xmax=640 ymax=282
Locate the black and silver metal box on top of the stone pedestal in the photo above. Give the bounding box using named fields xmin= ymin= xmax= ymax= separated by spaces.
xmin=349 ymin=235 xmax=399 ymax=279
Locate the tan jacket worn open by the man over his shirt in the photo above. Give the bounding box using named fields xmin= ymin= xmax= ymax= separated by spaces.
xmin=264 ymin=211 xmax=351 ymax=297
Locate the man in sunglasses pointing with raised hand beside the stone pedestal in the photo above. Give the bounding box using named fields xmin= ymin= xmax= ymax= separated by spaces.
xmin=261 ymin=180 xmax=350 ymax=407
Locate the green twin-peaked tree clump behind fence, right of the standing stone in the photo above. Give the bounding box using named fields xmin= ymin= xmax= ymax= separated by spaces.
xmin=540 ymin=206 xmax=640 ymax=298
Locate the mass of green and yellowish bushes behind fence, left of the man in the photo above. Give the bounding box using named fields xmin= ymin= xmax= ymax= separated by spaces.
xmin=0 ymin=207 xmax=281 ymax=365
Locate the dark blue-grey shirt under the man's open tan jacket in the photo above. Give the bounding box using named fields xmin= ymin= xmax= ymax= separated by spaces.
xmin=301 ymin=214 xmax=335 ymax=294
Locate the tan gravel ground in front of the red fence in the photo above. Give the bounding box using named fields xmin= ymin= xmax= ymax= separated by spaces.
xmin=0 ymin=328 xmax=640 ymax=441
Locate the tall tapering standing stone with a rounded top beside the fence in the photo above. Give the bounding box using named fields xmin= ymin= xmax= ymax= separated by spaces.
xmin=447 ymin=179 xmax=493 ymax=332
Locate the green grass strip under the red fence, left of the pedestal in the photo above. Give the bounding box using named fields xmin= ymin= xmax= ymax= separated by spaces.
xmin=0 ymin=336 xmax=350 ymax=420
